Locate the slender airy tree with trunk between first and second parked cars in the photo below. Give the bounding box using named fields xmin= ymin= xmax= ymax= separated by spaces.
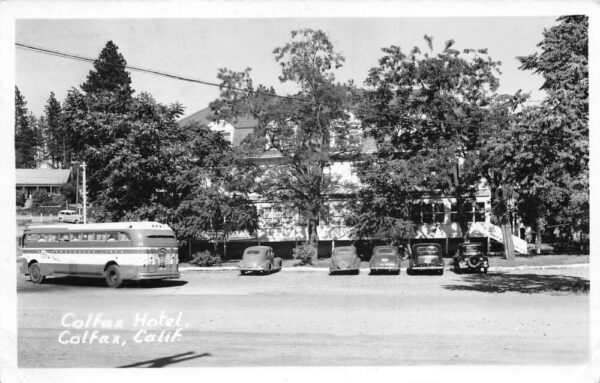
xmin=211 ymin=29 xmax=355 ymax=258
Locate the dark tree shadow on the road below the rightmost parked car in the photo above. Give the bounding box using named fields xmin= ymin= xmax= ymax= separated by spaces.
xmin=444 ymin=273 xmax=590 ymax=294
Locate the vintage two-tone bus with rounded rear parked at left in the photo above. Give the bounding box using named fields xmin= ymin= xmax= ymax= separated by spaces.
xmin=19 ymin=222 xmax=180 ymax=288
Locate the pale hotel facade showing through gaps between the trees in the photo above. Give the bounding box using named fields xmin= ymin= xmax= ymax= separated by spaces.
xmin=180 ymin=108 xmax=522 ymax=258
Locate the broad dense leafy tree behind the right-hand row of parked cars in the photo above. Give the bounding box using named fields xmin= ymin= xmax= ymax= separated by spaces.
xmin=350 ymin=36 xmax=500 ymax=249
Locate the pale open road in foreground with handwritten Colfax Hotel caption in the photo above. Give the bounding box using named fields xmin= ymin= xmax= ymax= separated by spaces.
xmin=17 ymin=268 xmax=589 ymax=367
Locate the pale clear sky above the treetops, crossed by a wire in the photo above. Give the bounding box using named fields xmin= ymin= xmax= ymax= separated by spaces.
xmin=15 ymin=16 xmax=556 ymax=116
